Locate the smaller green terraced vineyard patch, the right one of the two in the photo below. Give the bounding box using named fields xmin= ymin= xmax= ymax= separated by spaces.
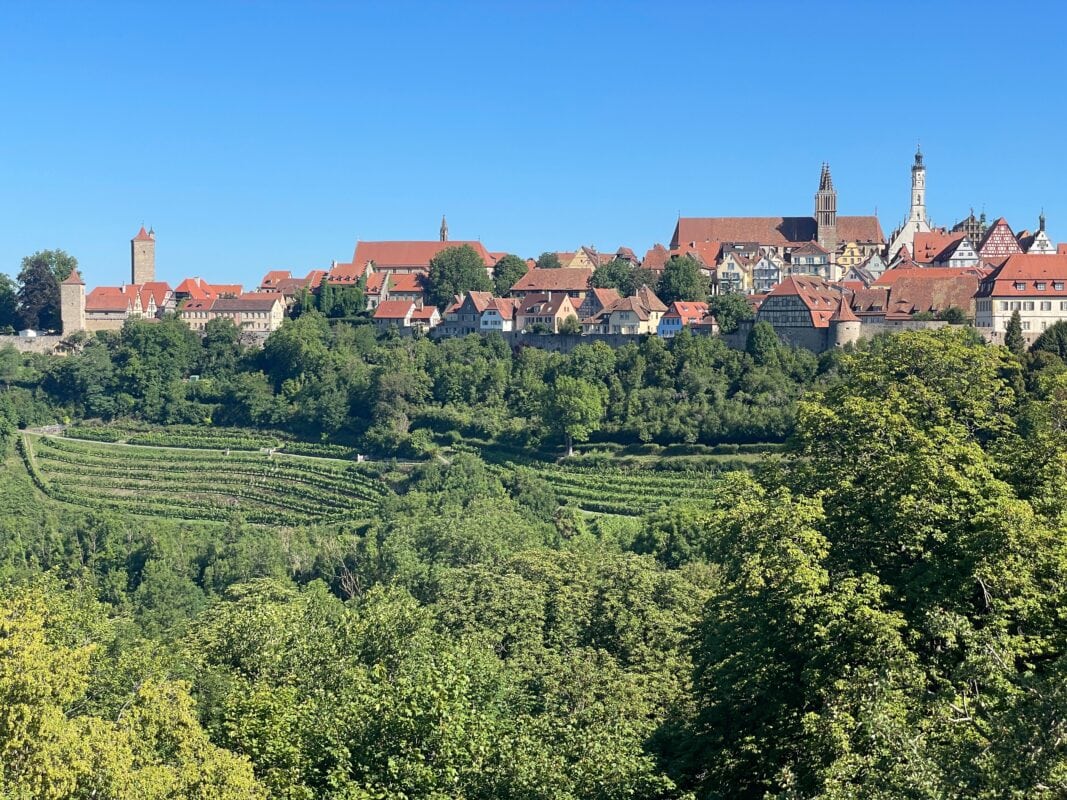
xmin=499 ymin=464 xmax=715 ymax=516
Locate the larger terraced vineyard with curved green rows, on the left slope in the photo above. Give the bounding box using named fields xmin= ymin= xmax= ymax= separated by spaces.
xmin=20 ymin=435 xmax=387 ymax=525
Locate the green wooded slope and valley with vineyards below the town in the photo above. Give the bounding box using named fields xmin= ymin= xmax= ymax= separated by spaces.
xmin=0 ymin=322 xmax=1067 ymax=800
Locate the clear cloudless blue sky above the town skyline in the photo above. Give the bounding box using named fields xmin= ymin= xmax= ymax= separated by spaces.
xmin=0 ymin=0 xmax=1067 ymax=286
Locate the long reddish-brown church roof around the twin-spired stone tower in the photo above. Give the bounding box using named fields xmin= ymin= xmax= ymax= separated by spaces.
xmin=671 ymin=217 xmax=886 ymax=247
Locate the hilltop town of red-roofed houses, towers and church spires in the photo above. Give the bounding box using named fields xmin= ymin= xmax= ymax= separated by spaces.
xmin=18 ymin=151 xmax=1067 ymax=352
